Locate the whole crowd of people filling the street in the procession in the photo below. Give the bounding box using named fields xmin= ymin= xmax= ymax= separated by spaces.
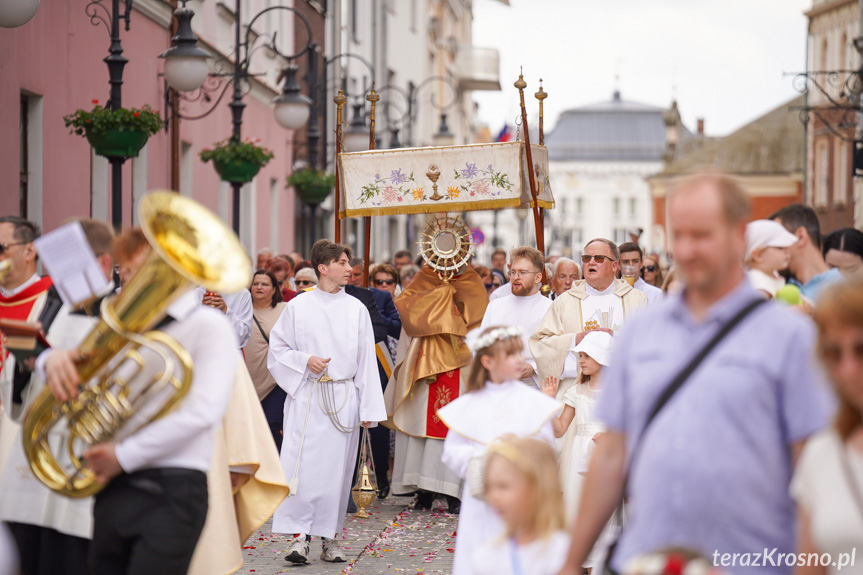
xmin=0 ymin=169 xmax=863 ymax=575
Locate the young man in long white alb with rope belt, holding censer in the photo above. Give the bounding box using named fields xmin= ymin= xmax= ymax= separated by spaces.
xmin=267 ymin=240 xmax=387 ymax=563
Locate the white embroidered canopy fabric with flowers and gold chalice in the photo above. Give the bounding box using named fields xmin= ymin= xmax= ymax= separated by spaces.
xmin=339 ymin=142 xmax=554 ymax=217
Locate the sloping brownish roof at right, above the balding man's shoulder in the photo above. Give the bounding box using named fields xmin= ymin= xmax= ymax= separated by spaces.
xmin=660 ymin=95 xmax=805 ymax=175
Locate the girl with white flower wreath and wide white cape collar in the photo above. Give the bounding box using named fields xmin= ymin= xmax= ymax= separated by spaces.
xmin=437 ymin=327 xmax=560 ymax=575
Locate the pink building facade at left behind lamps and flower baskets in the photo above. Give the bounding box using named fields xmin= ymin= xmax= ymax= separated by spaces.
xmin=0 ymin=0 xmax=296 ymax=255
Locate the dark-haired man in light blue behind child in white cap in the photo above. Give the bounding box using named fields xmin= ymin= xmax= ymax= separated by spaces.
xmin=770 ymin=204 xmax=842 ymax=304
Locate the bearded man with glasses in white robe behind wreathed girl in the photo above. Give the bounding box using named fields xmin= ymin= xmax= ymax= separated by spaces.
xmin=479 ymin=246 xmax=551 ymax=387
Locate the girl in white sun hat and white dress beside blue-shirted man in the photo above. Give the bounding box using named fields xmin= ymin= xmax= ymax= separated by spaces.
xmin=542 ymin=331 xmax=620 ymax=568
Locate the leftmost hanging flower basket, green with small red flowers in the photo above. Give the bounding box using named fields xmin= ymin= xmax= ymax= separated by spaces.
xmin=63 ymin=100 xmax=162 ymax=158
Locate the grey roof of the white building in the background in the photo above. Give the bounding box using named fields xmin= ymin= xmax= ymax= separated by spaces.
xmin=545 ymin=92 xmax=666 ymax=162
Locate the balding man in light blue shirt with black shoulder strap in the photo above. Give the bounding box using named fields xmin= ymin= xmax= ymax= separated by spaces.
xmin=563 ymin=174 xmax=831 ymax=574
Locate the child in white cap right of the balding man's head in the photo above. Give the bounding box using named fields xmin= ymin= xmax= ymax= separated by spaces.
xmin=744 ymin=220 xmax=797 ymax=299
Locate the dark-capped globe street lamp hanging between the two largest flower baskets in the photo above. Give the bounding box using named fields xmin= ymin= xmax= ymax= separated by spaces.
xmin=159 ymin=0 xmax=210 ymax=92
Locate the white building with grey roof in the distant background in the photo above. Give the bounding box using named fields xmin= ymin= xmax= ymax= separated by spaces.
xmin=545 ymin=92 xmax=668 ymax=256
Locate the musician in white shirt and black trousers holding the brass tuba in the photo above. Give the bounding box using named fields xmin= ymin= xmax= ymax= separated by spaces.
xmin=44 ymin=242 xmax=238 ymax=575
